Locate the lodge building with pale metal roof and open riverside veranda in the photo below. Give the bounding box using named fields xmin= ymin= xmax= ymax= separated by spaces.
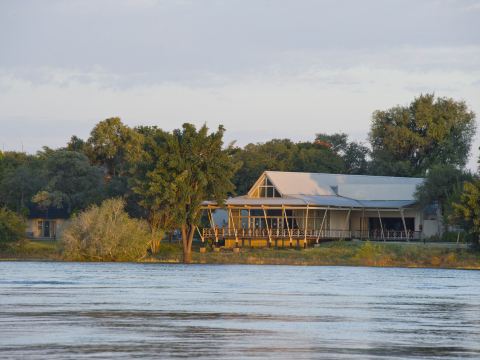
xmin=197 ymin=171 xmax=442 ymax=247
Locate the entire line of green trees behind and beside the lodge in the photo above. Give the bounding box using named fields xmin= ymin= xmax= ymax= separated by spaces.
xmin=0 ymin=94 xmax=480 ymax=258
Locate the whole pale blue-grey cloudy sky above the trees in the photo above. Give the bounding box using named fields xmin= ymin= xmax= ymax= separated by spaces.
xmin=0 ymin=0 xmax=480 ymax=170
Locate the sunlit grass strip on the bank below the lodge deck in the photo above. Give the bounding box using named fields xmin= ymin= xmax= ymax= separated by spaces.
xmin=162 ymin=241 xmax=480 ymax=269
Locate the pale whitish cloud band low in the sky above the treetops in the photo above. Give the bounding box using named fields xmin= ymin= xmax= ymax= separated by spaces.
xmin=0 ymin=54 xmax=480 ymax=168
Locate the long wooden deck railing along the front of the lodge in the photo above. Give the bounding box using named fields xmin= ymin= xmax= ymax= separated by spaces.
xmin=202 ymin=227 xmax=421 ymax=241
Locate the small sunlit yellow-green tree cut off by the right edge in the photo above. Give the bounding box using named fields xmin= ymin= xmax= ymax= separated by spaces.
xmin=452 ymin=179 xmax=480 ymax=246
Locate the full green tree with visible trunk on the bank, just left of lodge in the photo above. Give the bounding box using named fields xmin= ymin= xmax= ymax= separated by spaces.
xmin=134 ymin=124 xmax=237 ymax=263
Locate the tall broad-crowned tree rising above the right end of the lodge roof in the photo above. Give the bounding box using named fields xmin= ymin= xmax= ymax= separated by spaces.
xmin=369 ymin=94 xmax=475 ymax=176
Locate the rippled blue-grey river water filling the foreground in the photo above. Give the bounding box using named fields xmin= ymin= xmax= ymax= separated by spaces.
xmin=0 ymin=262 xmax=480 ymax=359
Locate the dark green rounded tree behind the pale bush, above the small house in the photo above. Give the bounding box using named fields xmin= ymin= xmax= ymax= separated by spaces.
xmin=33 ymin=150 xmax=103 ymax=214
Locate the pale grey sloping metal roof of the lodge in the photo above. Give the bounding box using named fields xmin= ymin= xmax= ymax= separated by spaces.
xmin=203 ymin=171 xmax=423 ymax=209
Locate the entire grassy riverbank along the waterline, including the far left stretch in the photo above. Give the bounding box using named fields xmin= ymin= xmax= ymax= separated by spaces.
xmin=0 ymin=241 xmax=480 ymax=270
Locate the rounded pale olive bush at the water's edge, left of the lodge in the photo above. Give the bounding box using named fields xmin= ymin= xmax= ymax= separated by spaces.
xmin=62 ymin=199 xmax=159 ymax=261
